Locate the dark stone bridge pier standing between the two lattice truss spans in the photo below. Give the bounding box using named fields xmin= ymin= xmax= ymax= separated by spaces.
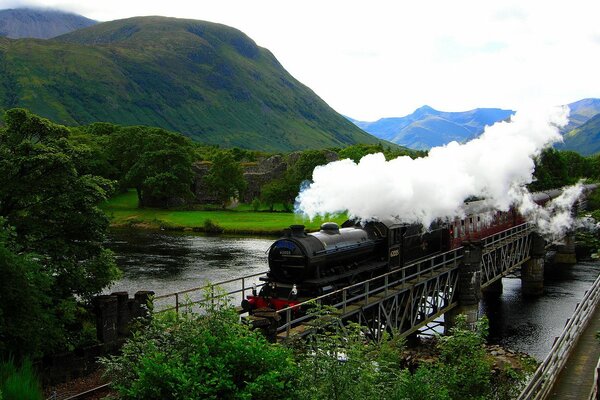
xmin=444 ymin=243 xmax=483 ymax=333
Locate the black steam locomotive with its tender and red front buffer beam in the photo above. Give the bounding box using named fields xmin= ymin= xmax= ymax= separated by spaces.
xmin=244 ymin=221 xmax=450 ymax=311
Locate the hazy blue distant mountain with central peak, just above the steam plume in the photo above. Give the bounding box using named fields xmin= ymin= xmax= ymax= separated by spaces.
xmin=350 ymin=106 xmax=514 ymax=150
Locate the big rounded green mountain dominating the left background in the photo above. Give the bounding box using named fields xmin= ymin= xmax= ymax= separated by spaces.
xmin=0 ymin=17 xmax=379 ymax=151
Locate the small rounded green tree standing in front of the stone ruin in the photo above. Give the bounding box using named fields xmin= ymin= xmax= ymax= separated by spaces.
xmin=204 ymin=151 xmax=246 ymax=208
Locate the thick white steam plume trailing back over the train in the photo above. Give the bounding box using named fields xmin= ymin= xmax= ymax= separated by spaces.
xmin=296 ymin=107 xmax=582 ymax=238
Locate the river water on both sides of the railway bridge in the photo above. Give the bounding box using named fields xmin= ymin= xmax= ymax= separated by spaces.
xmin=108 ymin=230 xmax=600 ymax=360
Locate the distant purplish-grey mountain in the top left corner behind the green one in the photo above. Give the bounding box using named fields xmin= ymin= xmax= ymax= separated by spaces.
xmin=0 ymin=8 xmax=97 ymax=39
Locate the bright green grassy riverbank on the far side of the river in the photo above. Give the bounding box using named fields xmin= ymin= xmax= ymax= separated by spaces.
xmin=102 ymin=190 xmax=346 ymax=234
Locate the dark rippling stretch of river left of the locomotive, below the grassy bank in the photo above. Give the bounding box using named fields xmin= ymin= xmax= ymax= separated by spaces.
xmin=107 ymin=230 xmax=273 ymax=295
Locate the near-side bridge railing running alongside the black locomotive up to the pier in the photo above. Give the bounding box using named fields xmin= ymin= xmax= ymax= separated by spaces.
xmin=277 ymin=247 xmax=463 ymax=337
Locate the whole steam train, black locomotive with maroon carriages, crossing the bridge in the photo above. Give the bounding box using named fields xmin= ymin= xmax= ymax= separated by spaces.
xmin=242 ymin=185 xmax=597 ymax=314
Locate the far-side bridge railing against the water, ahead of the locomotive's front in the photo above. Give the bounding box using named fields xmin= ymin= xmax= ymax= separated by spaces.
xmin=153 ymin=271 xmax=267 ymax=313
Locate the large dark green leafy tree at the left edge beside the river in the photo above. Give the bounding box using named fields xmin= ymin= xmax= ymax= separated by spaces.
xmin=0 ymin=109 xmax=118 ymax=356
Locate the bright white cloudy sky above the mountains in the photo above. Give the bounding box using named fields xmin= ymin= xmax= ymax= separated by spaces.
xmin=0 ymin=0 xmax=600 ymax=120
